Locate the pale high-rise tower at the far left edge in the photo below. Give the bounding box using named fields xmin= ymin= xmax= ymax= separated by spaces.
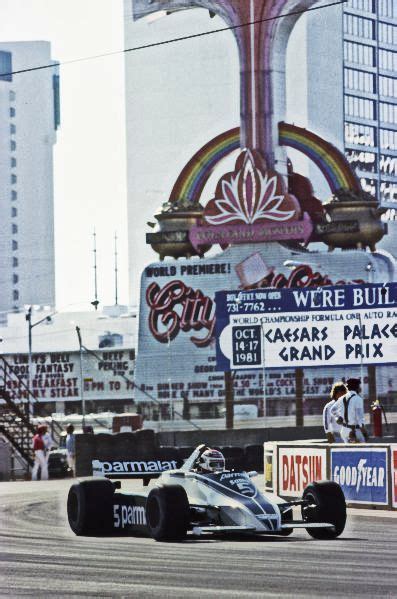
xmin=0 ymin=41 xmax=59 ymax=318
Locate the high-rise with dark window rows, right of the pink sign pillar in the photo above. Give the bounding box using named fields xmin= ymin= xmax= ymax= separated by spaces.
xmin=287 ymin=0 xmax=397 ymax=206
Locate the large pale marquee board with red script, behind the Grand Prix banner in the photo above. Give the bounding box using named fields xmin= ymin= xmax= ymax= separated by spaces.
xmin=135 ymin=243 xmax=397 ymax=407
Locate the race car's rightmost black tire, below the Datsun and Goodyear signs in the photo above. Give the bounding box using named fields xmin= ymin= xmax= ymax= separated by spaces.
xmin=302 ymin=481 xmax=346 ymax=539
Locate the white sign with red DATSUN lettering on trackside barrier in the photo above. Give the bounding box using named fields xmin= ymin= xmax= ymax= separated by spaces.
xmin=278 ymin=447 xmax=327 ymax=497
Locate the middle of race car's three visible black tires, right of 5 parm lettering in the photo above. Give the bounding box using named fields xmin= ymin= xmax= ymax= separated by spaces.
xmin=146 ymin=485 xmax=190 ymax=541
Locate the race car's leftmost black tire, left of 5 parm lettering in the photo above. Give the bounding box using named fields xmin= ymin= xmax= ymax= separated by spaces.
xmin=67 ymin=478 xmax=114 ymax=535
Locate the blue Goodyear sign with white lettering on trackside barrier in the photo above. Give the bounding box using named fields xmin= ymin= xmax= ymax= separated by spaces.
xmin=331 ymin=447 xmax=389 ymax=505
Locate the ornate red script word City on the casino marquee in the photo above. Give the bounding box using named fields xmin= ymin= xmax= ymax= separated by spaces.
xmin=146 ymin=281 xmax=215 ymax=347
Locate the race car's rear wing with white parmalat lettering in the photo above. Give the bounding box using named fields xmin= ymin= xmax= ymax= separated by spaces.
xmin=92 ymin=459 xmax=178 ymax=485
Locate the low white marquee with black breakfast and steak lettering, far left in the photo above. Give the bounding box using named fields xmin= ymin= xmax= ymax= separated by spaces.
xmin=4 ymin=349 xmax=135 ymax=401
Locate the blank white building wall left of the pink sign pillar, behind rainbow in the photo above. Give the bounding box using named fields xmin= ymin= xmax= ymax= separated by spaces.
xmin=124 ymin=7 xmax=240 ymax=304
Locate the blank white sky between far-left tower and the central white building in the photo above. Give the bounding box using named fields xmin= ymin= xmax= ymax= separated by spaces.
xmin=0 ymin=0 xmax=129 ymax=310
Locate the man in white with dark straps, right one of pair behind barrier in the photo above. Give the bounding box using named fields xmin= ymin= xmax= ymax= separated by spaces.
xmin=331 ymin=379 xmax=368 ymax=443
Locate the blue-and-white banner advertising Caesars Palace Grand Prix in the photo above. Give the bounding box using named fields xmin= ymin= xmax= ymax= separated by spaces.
xmin=215 ymin=283 xmax=397 ymax=370
